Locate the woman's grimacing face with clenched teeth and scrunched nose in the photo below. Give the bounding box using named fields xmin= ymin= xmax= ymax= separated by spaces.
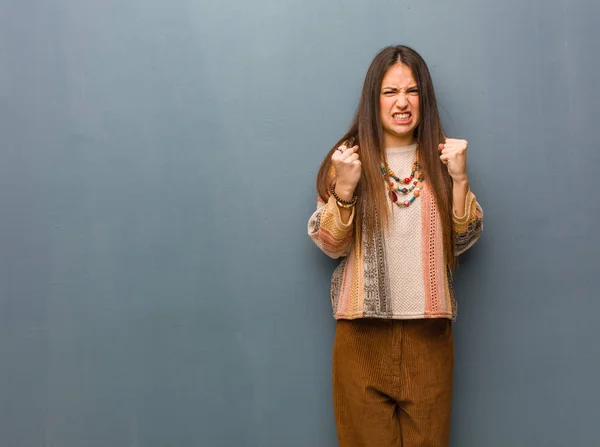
xmin=379 ymin=62 xmax=420 ymax=148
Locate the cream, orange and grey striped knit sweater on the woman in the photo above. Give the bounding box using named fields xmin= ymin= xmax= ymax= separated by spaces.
xmin=308 ymin=145 xmax=483 ymax=320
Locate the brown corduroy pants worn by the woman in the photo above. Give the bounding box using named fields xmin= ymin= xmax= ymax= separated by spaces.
xmin=333 ymin=318 xmax=454 ymax=447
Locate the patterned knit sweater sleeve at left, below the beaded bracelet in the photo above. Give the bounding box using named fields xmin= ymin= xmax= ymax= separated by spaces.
xmin=308 ymin=196 xmax=355 ymax=259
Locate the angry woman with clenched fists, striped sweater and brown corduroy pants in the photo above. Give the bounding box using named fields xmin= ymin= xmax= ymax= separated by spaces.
xmin=308 ymin=46 xmax=483 ymax=447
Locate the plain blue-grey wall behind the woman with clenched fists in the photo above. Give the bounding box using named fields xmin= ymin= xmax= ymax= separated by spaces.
xmin=0 ymin=0 xmax=600 ymax=447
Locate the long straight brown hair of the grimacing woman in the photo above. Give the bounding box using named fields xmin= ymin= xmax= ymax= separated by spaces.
xmin=317 ymin=45 xmax=456 ymax=268
